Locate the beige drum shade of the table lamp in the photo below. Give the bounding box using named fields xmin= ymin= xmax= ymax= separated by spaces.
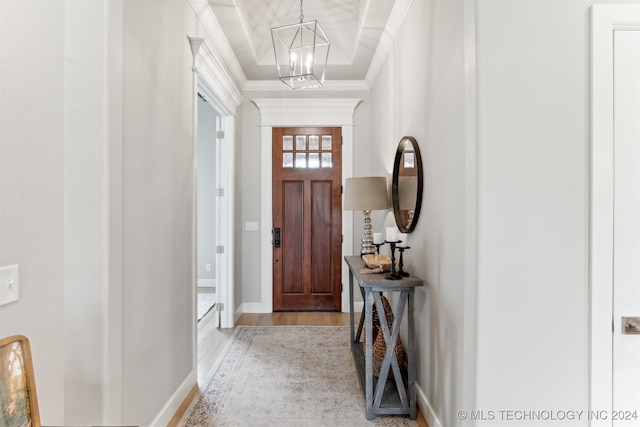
xmin=344 ymin=176 xmax=389 ymax=211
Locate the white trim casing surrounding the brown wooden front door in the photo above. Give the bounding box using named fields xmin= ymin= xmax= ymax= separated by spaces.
xmin=249 ymin=98 xmax=361 ymax=313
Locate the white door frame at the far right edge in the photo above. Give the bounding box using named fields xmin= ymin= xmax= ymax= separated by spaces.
xmin=590 ymin=4 xmax=640 ymax=426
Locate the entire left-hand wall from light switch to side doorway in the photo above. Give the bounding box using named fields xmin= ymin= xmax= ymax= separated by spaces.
xmin=0 ymin=0 xmax=222 ymax=426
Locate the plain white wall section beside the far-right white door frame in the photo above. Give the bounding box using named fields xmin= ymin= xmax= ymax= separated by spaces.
xmin=477 ymin=1 xmax=637 ymax=426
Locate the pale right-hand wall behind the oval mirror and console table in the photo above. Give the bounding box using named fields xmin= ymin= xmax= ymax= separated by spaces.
xmin=368 ymin=0 xmax=473 ymax=426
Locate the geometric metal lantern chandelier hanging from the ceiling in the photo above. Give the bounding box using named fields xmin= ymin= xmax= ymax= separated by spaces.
xmin=271 ymin=0 xmax=330 ymax=89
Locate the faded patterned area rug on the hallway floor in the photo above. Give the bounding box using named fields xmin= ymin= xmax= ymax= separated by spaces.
xmin=178 ymin=326 xmax=417 ymax=427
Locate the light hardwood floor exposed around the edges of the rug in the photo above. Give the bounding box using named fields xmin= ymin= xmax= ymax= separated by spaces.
xmin=168 ymin=311 xmax=429 ymax=427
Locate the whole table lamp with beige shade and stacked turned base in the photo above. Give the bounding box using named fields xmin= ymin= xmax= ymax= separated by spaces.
xmin=344 ymin=176 xmax=389 ymax=255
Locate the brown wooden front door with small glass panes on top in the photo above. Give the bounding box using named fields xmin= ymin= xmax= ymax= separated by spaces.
xmin=273 ymin=128 xmax=342 ymax=311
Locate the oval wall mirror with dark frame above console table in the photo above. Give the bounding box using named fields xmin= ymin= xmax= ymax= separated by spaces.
xmin=391 ymin=136 xmax=422 ymax=233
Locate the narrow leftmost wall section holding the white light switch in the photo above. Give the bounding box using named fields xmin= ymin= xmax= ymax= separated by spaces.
xmin=0 ymin=1 xmax=66 ymax=424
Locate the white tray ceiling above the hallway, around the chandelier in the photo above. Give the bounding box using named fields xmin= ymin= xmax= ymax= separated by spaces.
xmin=208 ymin=0 xmax=406 ymax=80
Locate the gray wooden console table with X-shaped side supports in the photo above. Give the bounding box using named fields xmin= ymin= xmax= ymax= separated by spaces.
xmin=344 ymin=256 xmax=422 ymax=420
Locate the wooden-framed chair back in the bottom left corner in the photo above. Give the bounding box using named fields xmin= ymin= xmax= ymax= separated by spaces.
xmin=0 ymin=335 xmax=40 ymax=427
